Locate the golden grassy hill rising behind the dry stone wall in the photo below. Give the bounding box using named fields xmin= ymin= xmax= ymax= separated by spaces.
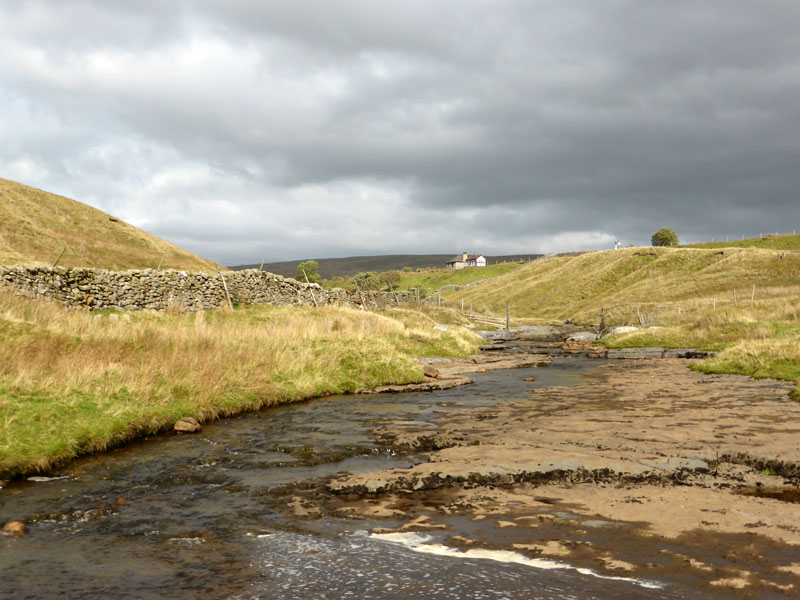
xmin=0 ymin=179 xmax=217 ymax=272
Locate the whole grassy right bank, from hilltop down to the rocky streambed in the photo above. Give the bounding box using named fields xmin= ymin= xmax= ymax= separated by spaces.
xmin=443 ymin=246 xmax=800 ymax=400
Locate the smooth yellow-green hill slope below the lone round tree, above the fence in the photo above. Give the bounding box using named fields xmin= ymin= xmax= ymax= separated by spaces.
xmin=445 ymin=247 xmax=800 ymax=323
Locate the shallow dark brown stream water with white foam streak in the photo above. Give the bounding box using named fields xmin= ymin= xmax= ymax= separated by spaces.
xmin=0 ymin=357 xmax=696 ymax=599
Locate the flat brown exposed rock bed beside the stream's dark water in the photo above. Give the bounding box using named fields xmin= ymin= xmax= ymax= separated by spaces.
xmin=318 ymin=359 xmax=800 ymax=598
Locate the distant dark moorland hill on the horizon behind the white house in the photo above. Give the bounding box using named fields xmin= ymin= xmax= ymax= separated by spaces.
xmin=230 ymin=253 xmax=541 ymax=279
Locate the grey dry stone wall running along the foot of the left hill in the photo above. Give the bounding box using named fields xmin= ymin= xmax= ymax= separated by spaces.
xmin=0 ymin=265 xmax=415 ymax=311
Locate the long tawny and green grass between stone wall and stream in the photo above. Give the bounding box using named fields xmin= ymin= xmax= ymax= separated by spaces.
xmin=0 ymin=290 xmax=478 ymax=477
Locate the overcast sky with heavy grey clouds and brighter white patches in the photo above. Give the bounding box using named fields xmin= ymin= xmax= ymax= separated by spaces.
xmin=0 ymin=0 xmax=800 ymax=265
